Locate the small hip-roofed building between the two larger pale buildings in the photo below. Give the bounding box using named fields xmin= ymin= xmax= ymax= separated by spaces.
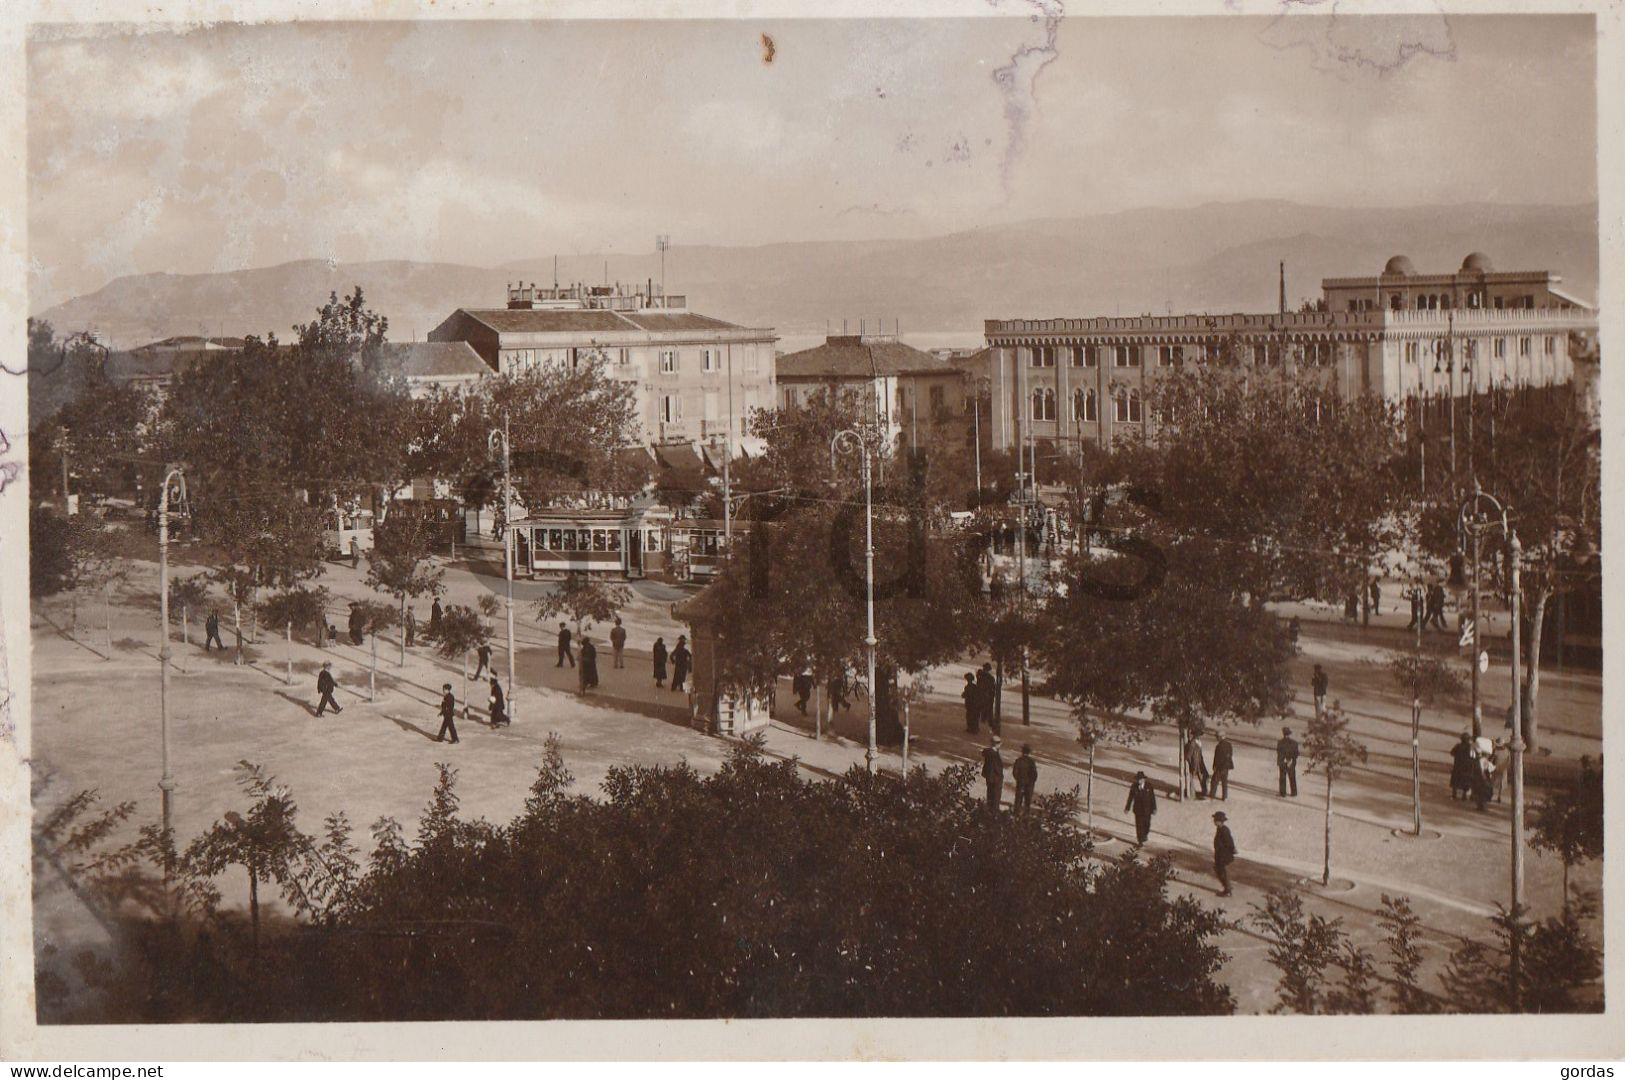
xmin=777 ymin=333 xmax=969 ymax=448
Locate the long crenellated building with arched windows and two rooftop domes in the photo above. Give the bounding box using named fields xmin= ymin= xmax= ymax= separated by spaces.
xmin=977 ymin=253 xmax=1597 ymax=450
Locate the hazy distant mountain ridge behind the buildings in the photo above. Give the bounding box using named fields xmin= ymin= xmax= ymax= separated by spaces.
xmin=37 ymin=201 xmax=1597 ymax=348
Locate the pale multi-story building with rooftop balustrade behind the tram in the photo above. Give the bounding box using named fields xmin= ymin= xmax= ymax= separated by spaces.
xmin=429 ymin=284 xmax=777 ymax=445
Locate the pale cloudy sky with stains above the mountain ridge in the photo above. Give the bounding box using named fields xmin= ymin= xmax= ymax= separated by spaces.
xmin=26 ymin=12 xmax=1597 ymax=310
